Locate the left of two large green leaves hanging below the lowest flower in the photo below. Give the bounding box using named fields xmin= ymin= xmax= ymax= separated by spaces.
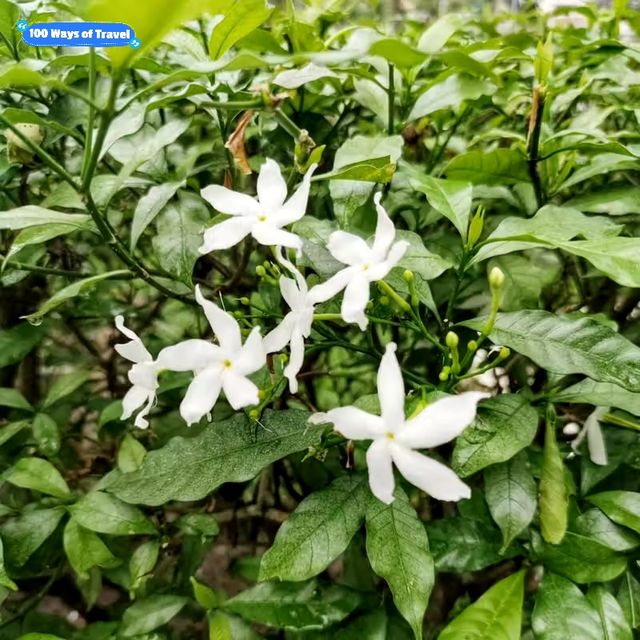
xmin=259 ymin=475 xmax=368 ymax=581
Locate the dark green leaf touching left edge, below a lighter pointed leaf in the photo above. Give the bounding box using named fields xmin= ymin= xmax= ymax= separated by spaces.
xmin=0 ymin=507 xmax=64 ymax=567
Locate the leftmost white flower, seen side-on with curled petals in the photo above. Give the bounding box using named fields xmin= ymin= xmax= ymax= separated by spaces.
xmin=114 ymin=316 xmax=158 ymax=429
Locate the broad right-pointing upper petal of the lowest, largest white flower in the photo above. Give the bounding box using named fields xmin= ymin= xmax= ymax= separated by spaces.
xmin=397 ymin=391 xmax=490 ymax=449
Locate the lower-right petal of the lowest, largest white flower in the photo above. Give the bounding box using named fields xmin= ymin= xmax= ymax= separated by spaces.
xmin=390 ymin=443 xmax=471 ymax=502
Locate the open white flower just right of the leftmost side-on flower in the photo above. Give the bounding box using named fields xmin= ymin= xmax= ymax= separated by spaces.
xmin=157 ymin=286 xmax=266 ymax=425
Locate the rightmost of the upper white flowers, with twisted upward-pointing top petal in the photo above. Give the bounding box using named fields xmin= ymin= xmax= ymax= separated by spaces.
xmin=316 ymin=193 xmax=409 ymax=331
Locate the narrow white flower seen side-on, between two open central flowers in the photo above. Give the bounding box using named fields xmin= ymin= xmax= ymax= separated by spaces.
xmin=263 ymin=256 xmax=328 ymax=393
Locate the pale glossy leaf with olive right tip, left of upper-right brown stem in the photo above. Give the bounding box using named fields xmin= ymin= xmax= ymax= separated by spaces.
xmin=407 ymin=73 xmax=496 ymax=121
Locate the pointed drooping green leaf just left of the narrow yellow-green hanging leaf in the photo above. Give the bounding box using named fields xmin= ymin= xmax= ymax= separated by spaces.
xmin=484 ymin=452 xmax=538 ymax=549
